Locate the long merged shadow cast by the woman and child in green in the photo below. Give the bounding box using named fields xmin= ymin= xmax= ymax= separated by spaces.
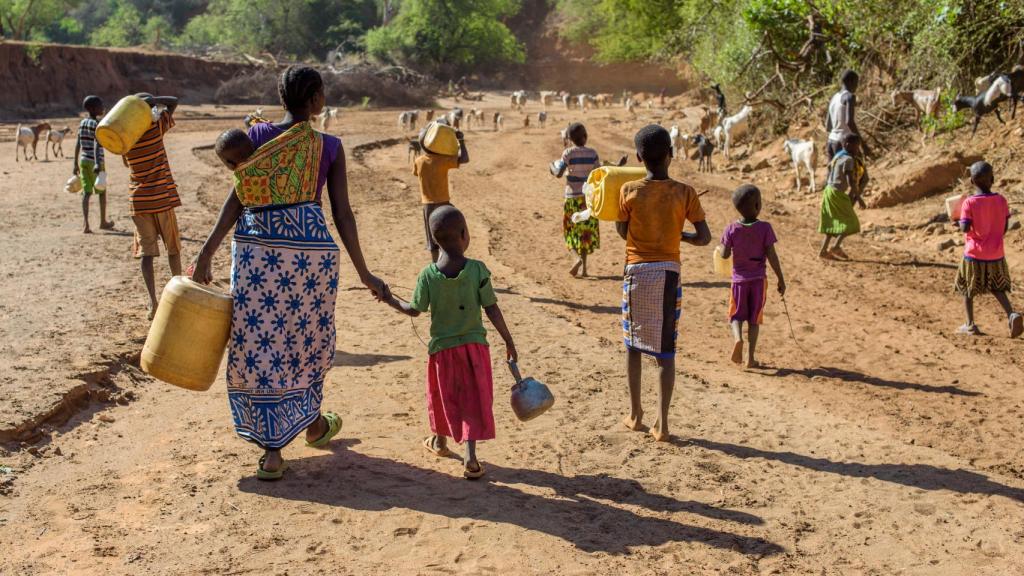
xmin=239 ymin=442 xmax=783 ymax=557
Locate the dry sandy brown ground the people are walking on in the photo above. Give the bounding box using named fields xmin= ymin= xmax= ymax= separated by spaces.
xmin=0 ymin=97 xmax=1024 ymax=575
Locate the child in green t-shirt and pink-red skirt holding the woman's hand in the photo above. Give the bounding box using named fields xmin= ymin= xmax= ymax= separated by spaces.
xmin=388 ymin=205 xmax=518 ymax=480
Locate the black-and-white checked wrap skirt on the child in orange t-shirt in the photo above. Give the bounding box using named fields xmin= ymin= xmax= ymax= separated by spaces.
xmin=623 ymin=262 xmax=683 ymax=358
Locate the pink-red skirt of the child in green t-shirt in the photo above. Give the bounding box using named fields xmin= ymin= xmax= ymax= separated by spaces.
xmin=427 ymin=344 xmax=495 ymax=444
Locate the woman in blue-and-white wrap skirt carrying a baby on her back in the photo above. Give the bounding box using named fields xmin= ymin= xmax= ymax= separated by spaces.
xmin=193 ymin=67 xmax=389 ymax=480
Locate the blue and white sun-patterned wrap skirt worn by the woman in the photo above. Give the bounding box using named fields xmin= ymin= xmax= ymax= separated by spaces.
xmin=227 ymin=203 xmax=340 ymax=450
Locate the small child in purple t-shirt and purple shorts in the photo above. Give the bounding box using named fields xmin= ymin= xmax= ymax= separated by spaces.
xmin=722 ymin=184 xmax=785 ymax=368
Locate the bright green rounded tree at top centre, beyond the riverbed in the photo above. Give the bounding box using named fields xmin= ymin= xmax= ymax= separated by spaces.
xmin=367 ymin=0 xmax=525 ymax=76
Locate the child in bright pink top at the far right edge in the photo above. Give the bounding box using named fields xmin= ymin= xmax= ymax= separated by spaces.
xmin=953 ymin=162 xmax=1024 ymax=338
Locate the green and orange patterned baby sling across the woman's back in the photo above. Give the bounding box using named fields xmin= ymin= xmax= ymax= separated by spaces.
xmin=234 ymin=122 xmax=324 ymax=207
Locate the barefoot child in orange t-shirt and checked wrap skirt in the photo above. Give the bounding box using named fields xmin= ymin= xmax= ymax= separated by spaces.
xmin=615 ymin=124 xmax=711 ymax=442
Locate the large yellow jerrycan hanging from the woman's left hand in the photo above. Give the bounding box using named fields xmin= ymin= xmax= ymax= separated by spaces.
xmin=139 ymin=276 xmax=231 ymax=392
